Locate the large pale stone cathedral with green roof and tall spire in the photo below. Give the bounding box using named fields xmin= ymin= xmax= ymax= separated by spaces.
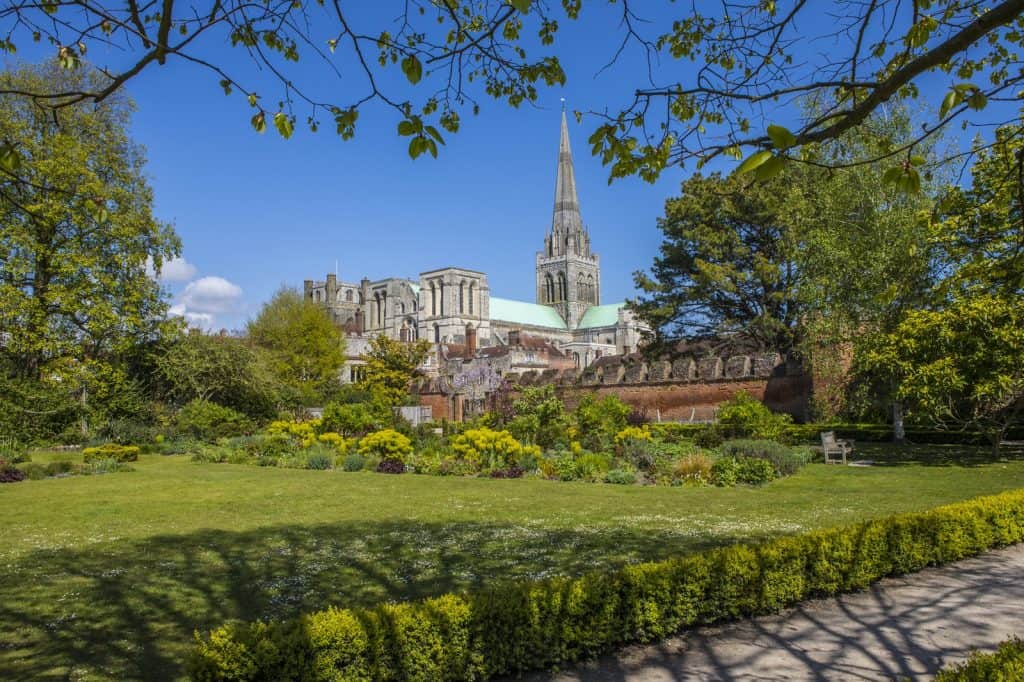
xmin=303 ymin=112 xmax=648 ymax=381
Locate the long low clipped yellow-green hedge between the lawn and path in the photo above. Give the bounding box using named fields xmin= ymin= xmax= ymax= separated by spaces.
xmin=190 ymin=491 xmax=1024 ymax=680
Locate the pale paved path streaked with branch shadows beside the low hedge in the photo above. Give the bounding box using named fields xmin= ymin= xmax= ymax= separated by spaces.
xmin=525 ymin=545 xmax=1024 ymax=682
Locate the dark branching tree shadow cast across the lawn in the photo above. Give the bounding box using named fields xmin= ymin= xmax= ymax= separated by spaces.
xmin=0 ymin=520 xmax=768 ymax=679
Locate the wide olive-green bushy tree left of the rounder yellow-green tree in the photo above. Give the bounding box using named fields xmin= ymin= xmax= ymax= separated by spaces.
xmin=153 ymin=331 xmax=281 ymax=418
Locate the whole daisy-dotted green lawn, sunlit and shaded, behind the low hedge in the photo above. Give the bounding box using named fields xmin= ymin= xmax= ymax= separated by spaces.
xmin=6 ymin=449 xmax=1024 ymax=679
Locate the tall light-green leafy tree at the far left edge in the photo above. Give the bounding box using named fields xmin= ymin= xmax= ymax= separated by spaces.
xmin=0 ymin=65 xmax=179 ymax=431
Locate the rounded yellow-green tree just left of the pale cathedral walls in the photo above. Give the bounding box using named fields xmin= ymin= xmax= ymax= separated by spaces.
xmin=247 ymin=288 xmax=345 ymax=406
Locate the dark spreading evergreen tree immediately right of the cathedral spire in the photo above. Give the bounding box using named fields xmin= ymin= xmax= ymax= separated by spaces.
xmin=634 ymin=168 xmax=803 ymax=352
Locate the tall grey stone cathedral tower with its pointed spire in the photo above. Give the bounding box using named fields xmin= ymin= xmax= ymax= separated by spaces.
xmin=537 ymin=110 xmax=601 ymax=329
